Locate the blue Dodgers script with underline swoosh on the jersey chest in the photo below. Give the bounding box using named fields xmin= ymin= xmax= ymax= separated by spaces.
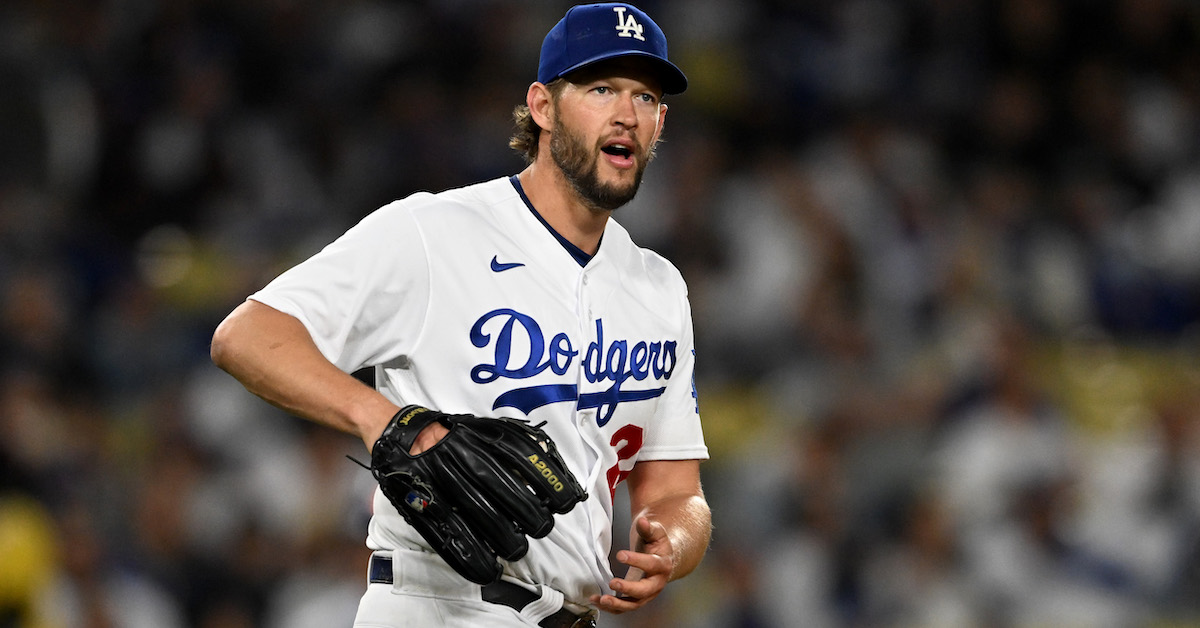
xmin=470 ymin=309 xmax=677 ymax=426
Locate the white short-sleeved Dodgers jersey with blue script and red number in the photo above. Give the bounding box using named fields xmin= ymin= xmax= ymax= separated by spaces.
xmin=252 ymin=177 xmax=708 ymax=604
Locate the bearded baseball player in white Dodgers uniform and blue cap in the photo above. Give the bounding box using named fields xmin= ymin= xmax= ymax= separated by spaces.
xmin=212 ymin=2 xmax=710 ymax=627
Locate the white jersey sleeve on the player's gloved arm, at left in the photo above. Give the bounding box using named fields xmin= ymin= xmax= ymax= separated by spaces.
xmin=250 ymin=202 xmax=430 ymax=372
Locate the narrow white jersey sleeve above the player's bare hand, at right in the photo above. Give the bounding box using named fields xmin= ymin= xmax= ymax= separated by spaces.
xmin=638 ymin=279 xmax=708 ymax=460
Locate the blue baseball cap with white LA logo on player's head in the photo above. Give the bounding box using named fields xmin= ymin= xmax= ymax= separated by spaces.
xmin=538 ymin=2 xmax=688 ymax=94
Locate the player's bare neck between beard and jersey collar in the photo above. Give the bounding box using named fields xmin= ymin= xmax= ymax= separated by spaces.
xmin=517 ymin=161 xmax=612 ymax=255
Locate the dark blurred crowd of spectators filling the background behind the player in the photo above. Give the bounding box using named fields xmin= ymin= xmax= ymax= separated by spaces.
xmin=7 ymin=0 xmax=1200 ymax=628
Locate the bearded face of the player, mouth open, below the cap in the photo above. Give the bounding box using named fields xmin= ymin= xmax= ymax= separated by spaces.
xmin=550 ymin=64 xmax=666 ymax=211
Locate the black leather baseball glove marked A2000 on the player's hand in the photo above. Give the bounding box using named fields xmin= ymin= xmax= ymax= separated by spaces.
xmin=370 ymin=406 xmax=587 ymax=585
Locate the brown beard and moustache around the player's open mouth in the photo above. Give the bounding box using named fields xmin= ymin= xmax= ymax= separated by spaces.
xmin=550 ymin=120 xmax=654 ymax=211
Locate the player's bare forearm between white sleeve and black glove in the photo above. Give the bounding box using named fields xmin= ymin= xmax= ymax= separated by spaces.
xmin=211 ymin=300 xmax=400 ymax=450
